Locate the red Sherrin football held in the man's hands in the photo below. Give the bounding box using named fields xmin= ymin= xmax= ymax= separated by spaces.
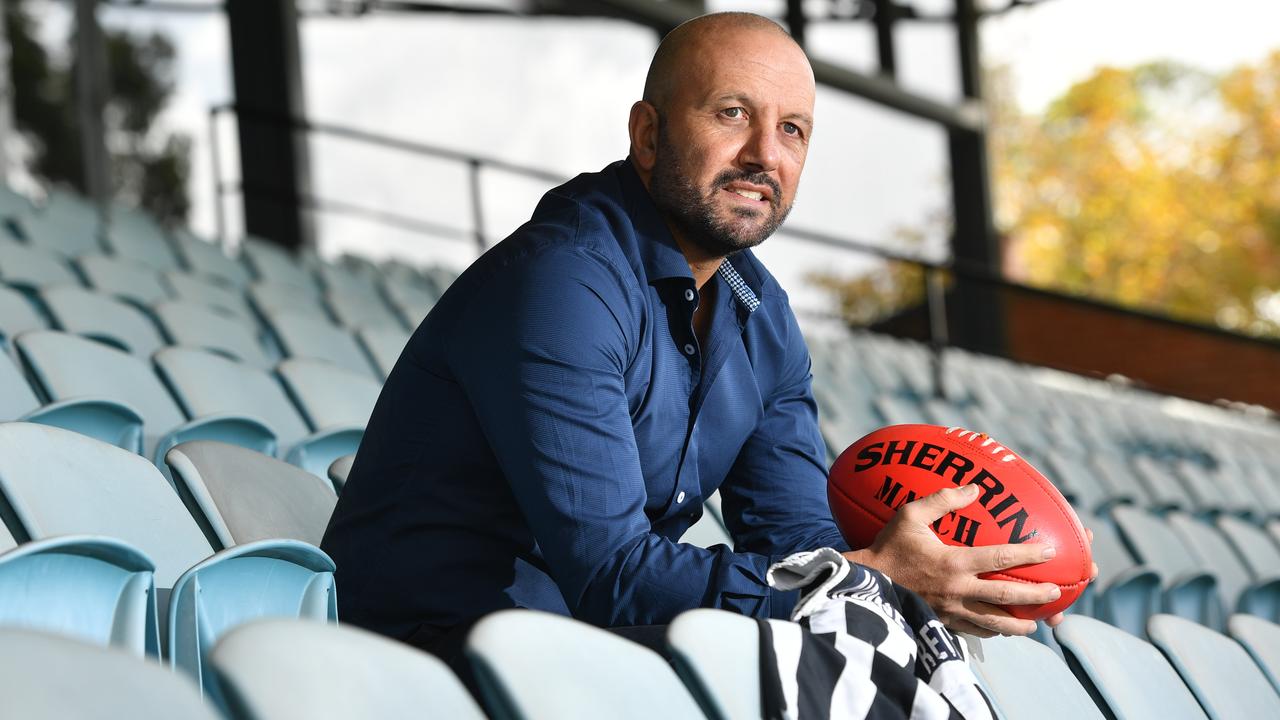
xmin=827 ymin=425 xmax=1093 ymax=620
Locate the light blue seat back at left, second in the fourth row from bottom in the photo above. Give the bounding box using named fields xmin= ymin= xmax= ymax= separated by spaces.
xmin=40 ymin=286 xmax=164 ymax=360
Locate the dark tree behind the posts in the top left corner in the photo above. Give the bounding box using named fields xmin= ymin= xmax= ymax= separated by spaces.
xmin=4 ymin=0 xmax=191 ymax=223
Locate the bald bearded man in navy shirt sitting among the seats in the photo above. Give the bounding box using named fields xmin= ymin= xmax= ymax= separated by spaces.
xmin=323 ymin=13 xmax=1057 ymax=655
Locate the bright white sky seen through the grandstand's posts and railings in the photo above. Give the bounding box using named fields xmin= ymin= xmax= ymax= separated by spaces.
xmin=27 ymin=0 xmax=1280 ymax=313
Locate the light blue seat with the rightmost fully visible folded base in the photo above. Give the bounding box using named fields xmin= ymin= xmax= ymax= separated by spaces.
xmin=1111 ymin=505 xmax=1225 ymax=628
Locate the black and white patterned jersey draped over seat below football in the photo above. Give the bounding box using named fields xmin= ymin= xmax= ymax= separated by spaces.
xmin=760 ymin=548 xmax=995 ymax=720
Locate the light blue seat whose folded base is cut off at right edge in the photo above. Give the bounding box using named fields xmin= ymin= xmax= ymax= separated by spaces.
xmin=1166 ymin=512 xmax=1280 ymax=621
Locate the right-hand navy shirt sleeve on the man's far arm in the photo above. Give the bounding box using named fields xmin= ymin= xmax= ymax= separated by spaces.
xmin=719 ymin=293 xmax=849 ymax=559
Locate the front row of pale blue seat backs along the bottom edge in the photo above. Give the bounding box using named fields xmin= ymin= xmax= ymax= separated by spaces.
xmin=0 ymin=599 xmax=1280 ymax=720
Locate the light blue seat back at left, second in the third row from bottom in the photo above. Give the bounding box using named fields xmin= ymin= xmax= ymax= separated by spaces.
xmin=17 ymin=331 xmax=183 ymax=456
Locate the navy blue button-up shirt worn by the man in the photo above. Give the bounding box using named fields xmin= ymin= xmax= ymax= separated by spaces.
xmin=323 ymin=160 xmax=847 ymax=639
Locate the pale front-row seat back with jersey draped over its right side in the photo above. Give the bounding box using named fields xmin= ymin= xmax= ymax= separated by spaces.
xmin=667 ymin=609 xmax=762 ymax=720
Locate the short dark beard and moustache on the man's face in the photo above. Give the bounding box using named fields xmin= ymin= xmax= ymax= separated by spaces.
xmin=649 ymin=117 xmax=791 ymax=258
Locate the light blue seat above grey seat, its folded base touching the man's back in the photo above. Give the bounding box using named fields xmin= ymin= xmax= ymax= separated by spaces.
xmin=155 ymin=347 xmax=369 ymax=478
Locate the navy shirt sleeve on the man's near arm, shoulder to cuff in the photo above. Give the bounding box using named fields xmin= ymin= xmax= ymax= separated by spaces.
xmin=448 ymin=240 xmax=790 ymax=626
